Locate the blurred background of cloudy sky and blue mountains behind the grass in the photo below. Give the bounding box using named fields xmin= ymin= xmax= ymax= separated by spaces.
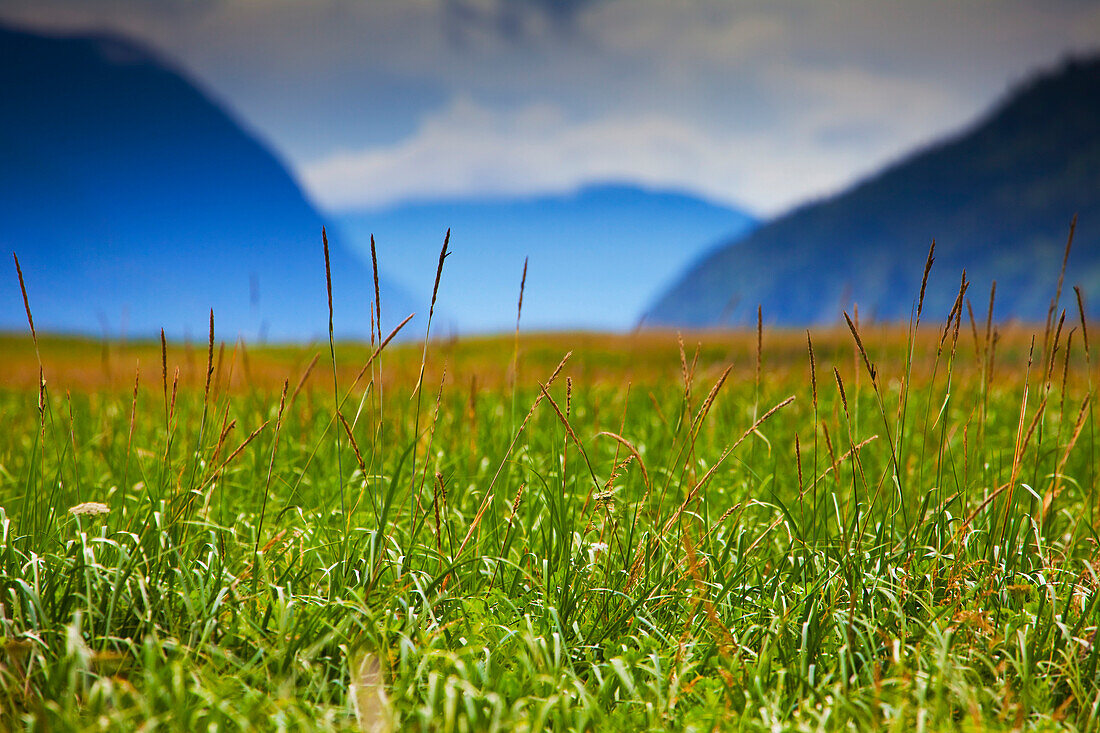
xmin=0 ymin=0 xmax=1100 ymax=341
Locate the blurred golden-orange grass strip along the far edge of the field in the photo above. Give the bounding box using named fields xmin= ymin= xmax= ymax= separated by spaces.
xmin=0 ymin=322 xmax=1085 ymax=400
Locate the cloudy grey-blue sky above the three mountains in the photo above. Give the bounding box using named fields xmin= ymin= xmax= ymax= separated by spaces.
xmin=0 ymin=0 xmax=1100 ymax=217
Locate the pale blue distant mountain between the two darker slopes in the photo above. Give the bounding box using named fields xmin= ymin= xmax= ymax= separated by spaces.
xmin=338 ymin=184 xmax=755 ymax=332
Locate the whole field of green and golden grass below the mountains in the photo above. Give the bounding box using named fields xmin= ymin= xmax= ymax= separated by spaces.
xmin=0 ymin=263 xmax=1100 ymax=731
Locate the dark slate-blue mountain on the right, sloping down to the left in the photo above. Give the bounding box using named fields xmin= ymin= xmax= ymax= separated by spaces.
xmin=644 ymin=58 xmax=1100 ymax=327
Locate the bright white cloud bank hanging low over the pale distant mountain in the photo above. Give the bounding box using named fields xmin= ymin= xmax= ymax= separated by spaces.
xmin=303 ymin=62 xmax=963 ymax=215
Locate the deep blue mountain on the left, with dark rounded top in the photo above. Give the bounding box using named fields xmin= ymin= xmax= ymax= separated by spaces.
xmin=0 ymin=29 xmax=408 ymax=340
